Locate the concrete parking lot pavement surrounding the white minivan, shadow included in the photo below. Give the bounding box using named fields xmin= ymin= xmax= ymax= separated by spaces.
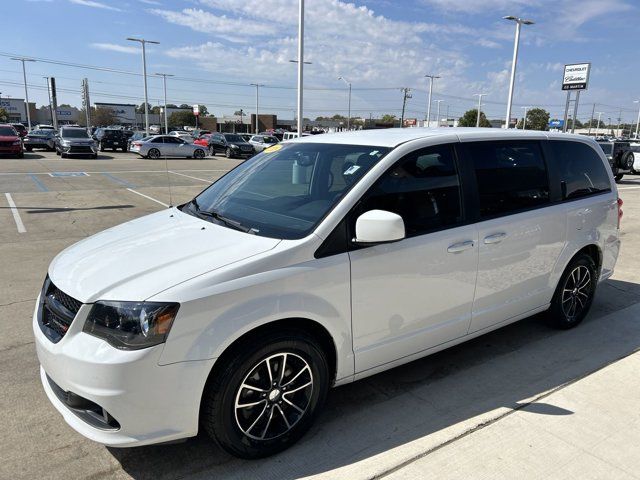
xmin=0 ymin=148 xmax=640 ymax=480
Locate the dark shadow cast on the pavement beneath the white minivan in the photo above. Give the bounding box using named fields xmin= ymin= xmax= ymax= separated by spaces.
xmin=109 ymin=280 xmax=640 ymax=480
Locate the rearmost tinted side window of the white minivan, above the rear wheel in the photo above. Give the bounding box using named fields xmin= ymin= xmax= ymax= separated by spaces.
xmin=549 ymin=141 xmax=611 ymax=198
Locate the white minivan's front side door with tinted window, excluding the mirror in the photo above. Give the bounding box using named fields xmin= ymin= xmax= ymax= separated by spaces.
xmin=349 ymin=145 xmax=478 ymax=373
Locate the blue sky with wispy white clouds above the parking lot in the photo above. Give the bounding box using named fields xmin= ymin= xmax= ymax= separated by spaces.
xmin=5 ymin=0 xmax=640 ymax=121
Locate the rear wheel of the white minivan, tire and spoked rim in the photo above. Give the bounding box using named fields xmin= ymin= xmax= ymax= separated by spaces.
xmin=548 ymin=253 xmax=598 ymax=330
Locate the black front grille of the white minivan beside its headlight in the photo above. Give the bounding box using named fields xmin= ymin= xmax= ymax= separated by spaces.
xmin=38 ymin=277 xmax=82 ymax=343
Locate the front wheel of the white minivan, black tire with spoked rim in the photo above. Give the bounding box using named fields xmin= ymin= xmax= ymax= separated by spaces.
xmin=201 ymin=331 xmax=329 ymax=459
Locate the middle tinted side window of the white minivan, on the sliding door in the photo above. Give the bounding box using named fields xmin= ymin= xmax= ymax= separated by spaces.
xmin=469 ymin=141 xmax=550 ymax=218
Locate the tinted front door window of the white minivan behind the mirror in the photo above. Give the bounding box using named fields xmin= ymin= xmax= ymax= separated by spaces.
xmin=358 ymin=145 xmax=462 ymax=237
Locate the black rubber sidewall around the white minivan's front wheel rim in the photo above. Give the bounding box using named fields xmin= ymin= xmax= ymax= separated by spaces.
xmin=205 ymin=335 xmax=329 ymax=458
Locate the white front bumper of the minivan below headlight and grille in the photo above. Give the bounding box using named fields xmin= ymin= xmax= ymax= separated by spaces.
xmin=33 ymin=298 xmax=214 ymax=447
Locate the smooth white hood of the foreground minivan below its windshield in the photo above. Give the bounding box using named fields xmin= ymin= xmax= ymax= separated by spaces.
xmin=49 ymin=208 xmax=280 ymax=303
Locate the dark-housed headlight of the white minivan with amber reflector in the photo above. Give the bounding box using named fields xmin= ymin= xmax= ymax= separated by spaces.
xmin=82 ymin=302 xmax=180 ymax=350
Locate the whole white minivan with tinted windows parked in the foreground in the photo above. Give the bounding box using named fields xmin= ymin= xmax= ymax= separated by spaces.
xmin=33 ymin=128 xmax=622 ymax=458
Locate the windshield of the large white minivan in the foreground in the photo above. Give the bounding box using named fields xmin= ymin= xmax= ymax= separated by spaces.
xmin=183 ymin=143 xmax=390 ymax=239
